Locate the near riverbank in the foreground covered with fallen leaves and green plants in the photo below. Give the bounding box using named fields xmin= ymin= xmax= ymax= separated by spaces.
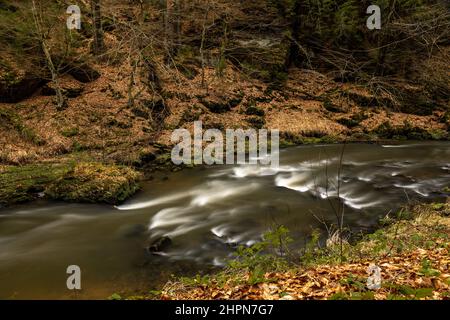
xmin=157 ymin=199 xmax=450 ymax=300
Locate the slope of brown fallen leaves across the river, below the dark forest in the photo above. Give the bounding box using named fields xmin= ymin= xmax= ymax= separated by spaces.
xmin=0 ymin=65 xmax=448 ymax=166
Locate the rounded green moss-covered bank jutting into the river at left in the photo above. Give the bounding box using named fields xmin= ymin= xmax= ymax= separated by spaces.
xmin=0 ymin=162 xmax=140 ymax=206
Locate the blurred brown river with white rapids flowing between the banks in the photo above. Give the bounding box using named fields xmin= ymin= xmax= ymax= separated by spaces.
xmin=0 ymin=142 xmax=450 ymax=299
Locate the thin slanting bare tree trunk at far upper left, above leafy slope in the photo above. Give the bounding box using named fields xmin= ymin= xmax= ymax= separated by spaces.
xmin=31 ymin=0 xmax=66 ymax=110
